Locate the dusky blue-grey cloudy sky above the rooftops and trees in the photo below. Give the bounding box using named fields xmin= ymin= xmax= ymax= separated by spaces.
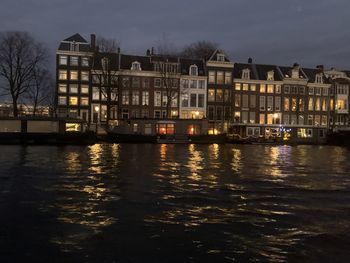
xmin=0 ymin=0 xmax=350 ymax=69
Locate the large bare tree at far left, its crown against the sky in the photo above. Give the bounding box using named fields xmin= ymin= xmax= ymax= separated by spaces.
xmin=0 ymin=32 xmax=47 ymax=117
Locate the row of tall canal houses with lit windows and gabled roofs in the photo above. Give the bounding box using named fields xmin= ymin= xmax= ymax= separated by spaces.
xmin=56 ymin=34 xmax=350 ymax=142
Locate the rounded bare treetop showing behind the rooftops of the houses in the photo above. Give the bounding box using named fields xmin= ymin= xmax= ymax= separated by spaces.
xmin=180 ymin=41 xmax=218 ymax=60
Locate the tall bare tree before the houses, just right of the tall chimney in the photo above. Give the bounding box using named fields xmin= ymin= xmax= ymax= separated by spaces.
xmin=92 ymin=37 xmax=119 ymax=129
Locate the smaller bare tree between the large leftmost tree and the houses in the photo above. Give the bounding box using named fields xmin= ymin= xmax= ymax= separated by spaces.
xmin=24 ymin=66 xmax=55 ymax=116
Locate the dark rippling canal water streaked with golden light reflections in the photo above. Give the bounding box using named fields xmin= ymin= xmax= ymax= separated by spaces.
xmin=0 ymin=144 xmax=350 ymax=262
